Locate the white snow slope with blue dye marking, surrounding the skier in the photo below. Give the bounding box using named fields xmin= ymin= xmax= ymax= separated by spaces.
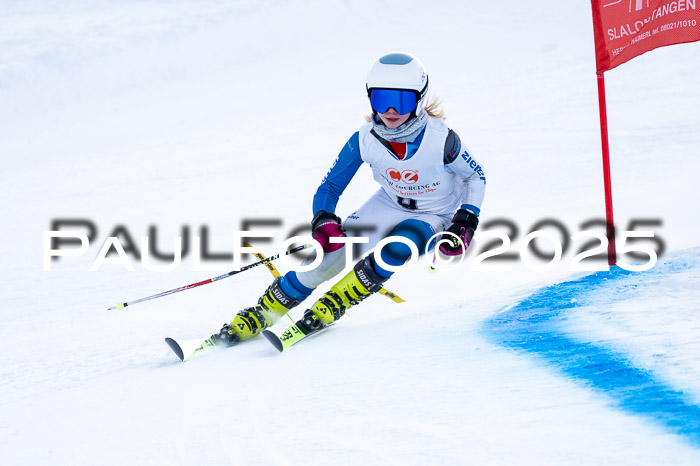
xmin=0 ymin=0 xmax=700 ymax=465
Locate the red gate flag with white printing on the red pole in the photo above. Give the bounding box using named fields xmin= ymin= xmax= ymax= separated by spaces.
xmin=591 ymin=0 xmax=700 ymax=73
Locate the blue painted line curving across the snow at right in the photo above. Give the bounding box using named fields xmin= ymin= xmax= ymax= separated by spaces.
xmin=484 ymin=263 xmax=700 ymax=446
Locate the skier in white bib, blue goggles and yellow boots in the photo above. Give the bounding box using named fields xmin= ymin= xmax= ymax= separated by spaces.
xmin=212 ymin=52 xmax=486 ymax=345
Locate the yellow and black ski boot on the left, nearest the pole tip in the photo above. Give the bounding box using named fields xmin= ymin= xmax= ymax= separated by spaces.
xmin=211 ymin=278 xmax=299 ymax=346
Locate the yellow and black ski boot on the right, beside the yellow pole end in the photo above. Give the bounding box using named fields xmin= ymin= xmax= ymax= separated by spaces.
xmin=298 ymin=254 xmax=387 ymax=335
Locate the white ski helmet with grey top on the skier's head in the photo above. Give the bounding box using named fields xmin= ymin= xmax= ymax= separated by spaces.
xmin=366 ymin=52 xmax=428 ymax=114
